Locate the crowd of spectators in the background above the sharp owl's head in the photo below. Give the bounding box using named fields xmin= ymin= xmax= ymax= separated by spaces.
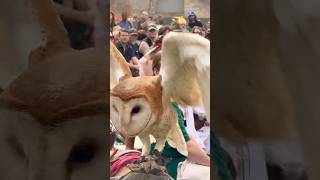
xmin=110 ymin=10 xmax=210 ymax=76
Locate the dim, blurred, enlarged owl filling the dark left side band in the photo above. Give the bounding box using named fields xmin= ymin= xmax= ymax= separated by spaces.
xmin=0 ymin=0 xmax=109 ymax=180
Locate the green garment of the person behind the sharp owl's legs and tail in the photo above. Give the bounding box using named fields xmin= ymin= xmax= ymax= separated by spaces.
xmin=150 ymin=103 xmax=190 ymax=179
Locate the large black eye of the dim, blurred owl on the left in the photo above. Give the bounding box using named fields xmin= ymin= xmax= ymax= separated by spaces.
xmin=68 ymin=145 xmax=96 ymax=163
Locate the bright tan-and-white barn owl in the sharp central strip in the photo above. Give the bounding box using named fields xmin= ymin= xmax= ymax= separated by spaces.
xmin=110 ymin=32 xmax=210 ymax=156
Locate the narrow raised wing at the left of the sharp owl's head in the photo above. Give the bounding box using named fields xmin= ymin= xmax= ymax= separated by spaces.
xmin=110 ymin=42 xmax=132 ymax=89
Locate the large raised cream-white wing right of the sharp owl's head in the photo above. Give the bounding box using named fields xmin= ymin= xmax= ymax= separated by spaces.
xmin=160 ymin=32 xmax=210 ymax=121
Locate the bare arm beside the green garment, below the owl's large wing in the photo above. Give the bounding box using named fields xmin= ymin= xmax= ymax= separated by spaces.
xmin=187 ymin=136 xmax=210 ymax=166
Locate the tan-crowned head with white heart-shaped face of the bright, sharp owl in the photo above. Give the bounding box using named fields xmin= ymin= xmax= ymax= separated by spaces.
xmin=110 ymin=76 xmax=163 ymax=136
